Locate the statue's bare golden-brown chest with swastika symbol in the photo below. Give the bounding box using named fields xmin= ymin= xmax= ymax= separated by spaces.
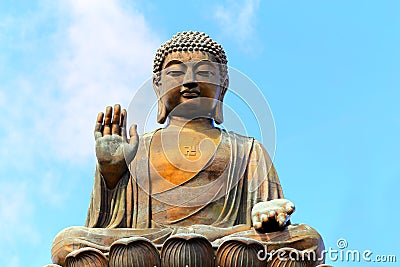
xmin=149 ymin=132 xmax=230 ymax=193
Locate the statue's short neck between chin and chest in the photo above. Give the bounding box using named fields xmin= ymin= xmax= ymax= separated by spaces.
xmin=166 ymin=116 xmax=215 ymax=131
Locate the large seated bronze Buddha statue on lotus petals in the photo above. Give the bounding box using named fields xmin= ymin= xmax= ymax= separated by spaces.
xmin=49 ymin=31 xmax=324 ymax=267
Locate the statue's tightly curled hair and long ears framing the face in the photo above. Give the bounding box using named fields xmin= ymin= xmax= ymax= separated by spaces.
xmin=153 ymin=31 xmax=229 ymax=124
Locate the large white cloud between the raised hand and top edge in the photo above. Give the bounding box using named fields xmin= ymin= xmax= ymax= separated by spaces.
xmin=52 ymin=0 xmax=160 ymax=161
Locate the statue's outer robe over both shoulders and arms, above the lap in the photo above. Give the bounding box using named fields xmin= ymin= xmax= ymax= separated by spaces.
xmin=86 ymin=131 xmax=283 ymax=232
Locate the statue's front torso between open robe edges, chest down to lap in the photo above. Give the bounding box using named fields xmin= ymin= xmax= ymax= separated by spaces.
xmin=149 ymin=130 xmax=230 ymax=226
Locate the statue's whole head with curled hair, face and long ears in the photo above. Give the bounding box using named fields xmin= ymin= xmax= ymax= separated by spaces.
xmin=153 ymin=31 xmax=229 ymax=124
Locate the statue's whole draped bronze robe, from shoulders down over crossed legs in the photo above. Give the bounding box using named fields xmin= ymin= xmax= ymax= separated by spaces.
xmin=52 ymin=130 xmax=324 ymax=264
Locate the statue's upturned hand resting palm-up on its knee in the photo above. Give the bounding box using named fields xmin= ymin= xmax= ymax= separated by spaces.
xmin=251 ymin=199 xmax=295 ymax=230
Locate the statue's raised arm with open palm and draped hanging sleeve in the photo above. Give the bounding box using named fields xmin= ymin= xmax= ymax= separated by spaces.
xmin=86 ymin=105 xmax=139 ymax=228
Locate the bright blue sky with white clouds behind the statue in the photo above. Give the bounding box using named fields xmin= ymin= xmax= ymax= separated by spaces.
xmin=0 ymin=0 xmax=400 ymax=266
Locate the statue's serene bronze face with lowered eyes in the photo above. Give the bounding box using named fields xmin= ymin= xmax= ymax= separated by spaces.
xmin=158 ymin=51 xmax=222 ymax=119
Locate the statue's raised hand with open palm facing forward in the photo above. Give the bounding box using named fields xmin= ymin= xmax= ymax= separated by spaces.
xmin=94 ymin=104 xmax=139 ymax=189
